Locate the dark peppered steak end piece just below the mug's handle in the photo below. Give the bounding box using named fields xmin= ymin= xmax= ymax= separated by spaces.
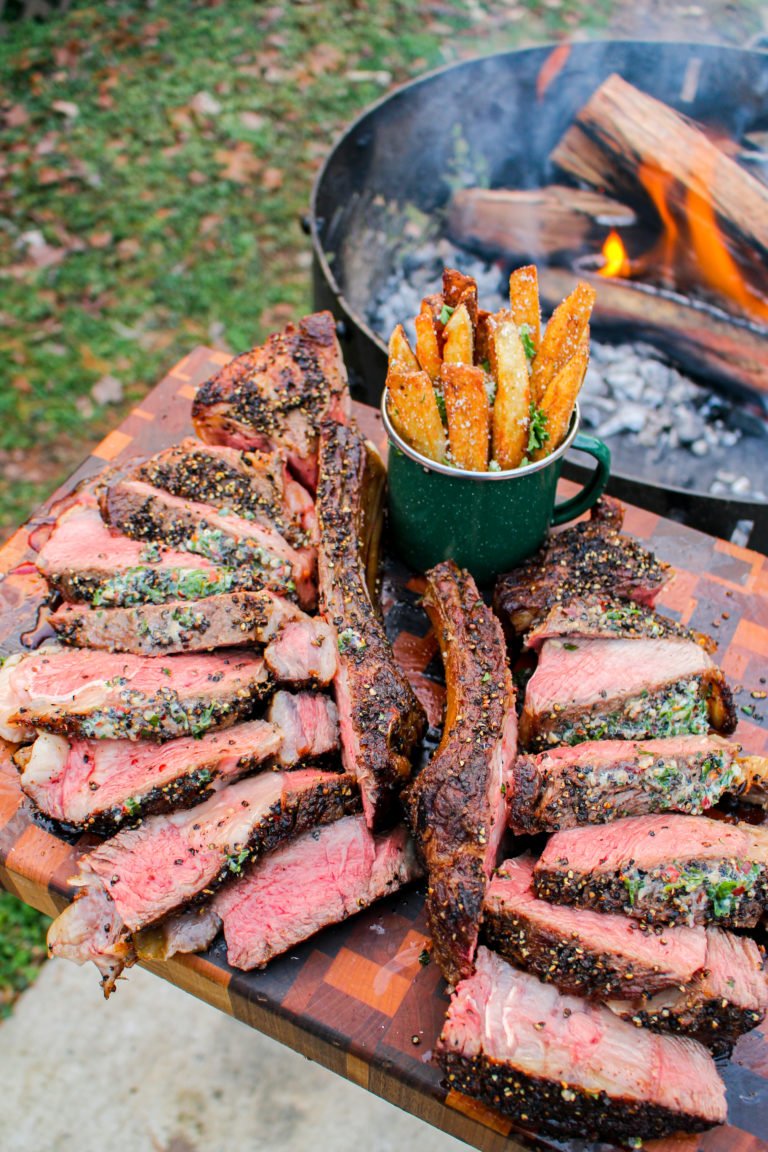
xmin=493 ymin=497 xmax=669 ymax=637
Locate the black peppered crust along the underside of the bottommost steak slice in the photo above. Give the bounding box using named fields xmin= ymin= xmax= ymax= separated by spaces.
xmin=438 ymin=1052 xmax=713 ymax=1142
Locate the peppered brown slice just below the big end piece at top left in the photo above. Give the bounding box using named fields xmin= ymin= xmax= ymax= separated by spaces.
xmin=128 ymin=437 xmax=317 ymax=548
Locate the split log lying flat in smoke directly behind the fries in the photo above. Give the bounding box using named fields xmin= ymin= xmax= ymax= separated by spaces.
xmin=448 ymin=184 xmax=637 ymax=260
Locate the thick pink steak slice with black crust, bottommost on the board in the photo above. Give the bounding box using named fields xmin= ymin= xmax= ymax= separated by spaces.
xmin=435 ymin=948 xmax=727 ymax=1143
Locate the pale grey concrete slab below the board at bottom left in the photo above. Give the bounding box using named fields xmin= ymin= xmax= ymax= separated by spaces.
xmin=0 ymin=960 xmax=466 ymax=1152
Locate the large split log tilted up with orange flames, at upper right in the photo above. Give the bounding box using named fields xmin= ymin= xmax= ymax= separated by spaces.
xmin=550 ymin=75 xmax=768 ymax=323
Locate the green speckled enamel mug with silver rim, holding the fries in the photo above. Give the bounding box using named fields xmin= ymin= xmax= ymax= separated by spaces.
xmin=381 ymin=389 xmax=610 ymax=586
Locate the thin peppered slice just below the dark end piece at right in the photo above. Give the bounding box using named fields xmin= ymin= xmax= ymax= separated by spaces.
xmin=525 ymin=596 xmax=717 ymax=654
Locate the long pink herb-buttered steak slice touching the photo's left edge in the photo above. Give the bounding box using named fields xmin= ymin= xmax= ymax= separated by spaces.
xmin=0 ymin=646 xmax=271 ymax=741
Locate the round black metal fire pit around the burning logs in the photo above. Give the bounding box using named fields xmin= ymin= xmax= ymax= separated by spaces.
xmin=309 ymin=41 xmax=768 ymax=552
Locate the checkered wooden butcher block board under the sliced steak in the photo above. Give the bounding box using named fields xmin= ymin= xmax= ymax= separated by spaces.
xmin=0 ymin=348 xmax=768 ymax=1152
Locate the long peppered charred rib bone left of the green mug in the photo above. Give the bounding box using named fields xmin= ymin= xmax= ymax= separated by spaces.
xmin=317 ymin=422 xmax=426 ymax=831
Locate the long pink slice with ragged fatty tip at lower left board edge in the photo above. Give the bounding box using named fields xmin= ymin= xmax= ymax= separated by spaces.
xmin=48 ymin=772 xmax=359 ymax=995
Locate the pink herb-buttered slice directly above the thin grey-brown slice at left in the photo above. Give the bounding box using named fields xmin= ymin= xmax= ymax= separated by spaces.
xmin=36 ymin=495 xmax=255 ymax=607
